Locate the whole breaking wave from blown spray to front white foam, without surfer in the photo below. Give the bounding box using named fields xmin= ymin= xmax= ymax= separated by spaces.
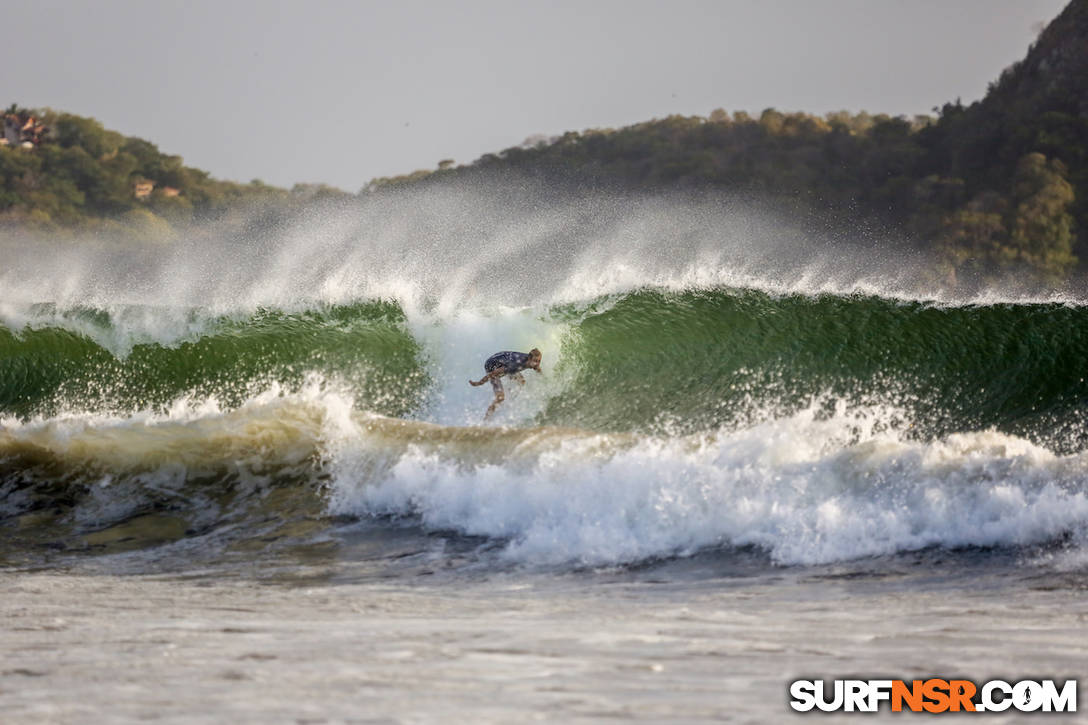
xmin=0 ymin=180 xmax=1088 ymax=565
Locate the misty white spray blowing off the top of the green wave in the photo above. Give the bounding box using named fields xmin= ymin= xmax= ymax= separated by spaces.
xmin=0 ymin=180 xmax=1075 ymax=326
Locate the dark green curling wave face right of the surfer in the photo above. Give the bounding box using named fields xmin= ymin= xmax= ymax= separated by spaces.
xmin=544 ymin=291 xmax=1088 ymax=439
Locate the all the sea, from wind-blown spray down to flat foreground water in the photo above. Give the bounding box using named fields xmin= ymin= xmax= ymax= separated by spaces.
xmin=0 ymin=184 xmax=1088 ymax=722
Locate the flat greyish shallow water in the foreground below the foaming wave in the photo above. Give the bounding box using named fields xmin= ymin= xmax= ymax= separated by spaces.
xmin=0 ymin=570 xmax=1088 ymax=724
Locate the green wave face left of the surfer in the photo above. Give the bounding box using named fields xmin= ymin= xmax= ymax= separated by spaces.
xmin=0 ymin=303 xmax=428 ymax=417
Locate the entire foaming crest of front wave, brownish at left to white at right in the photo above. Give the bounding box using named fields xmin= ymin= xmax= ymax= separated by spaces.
xmin=8 ymin=378 xmax=1088 ymax=568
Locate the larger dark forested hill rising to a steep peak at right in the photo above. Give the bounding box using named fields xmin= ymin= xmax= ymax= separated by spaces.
xmin=371 ymin=0 xmax=1088 ymax=283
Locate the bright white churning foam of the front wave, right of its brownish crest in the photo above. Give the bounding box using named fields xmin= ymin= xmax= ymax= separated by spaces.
xmin=331 ymin=400 xmax=1088 ymax=565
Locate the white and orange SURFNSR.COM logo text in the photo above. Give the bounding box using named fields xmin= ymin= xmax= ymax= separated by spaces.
xmin=790 ymin=677 xmax=1077 ymax=713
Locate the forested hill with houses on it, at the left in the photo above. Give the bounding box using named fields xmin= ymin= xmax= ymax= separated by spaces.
xmin=0 ymin=105 xmax=346 ymax=242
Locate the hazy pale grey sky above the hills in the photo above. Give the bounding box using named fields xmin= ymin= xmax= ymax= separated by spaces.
xmin=0 ymin=0 xmax=1065 ymax=191
